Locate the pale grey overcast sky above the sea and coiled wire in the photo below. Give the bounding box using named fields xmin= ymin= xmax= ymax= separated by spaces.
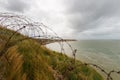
xmin=0 ymin=0 xmax=120 ymax=39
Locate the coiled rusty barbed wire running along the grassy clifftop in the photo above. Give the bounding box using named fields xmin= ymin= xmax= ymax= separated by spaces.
xmin=0 ymin=13 xmax=120 ymax=80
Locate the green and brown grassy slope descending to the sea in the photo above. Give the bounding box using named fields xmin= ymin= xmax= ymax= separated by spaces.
xmin=0 ymin=28 xmax=103 ymax=80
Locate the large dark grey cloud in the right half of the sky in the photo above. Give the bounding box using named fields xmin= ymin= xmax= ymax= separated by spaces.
xmin=65 ymin=0 xmax=120 ymax=32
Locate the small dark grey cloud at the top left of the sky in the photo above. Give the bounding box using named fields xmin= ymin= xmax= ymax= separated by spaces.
xmin=4 ymin=0 xmax=30 ymax=12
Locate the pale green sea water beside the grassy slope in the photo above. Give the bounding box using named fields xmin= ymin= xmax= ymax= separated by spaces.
xmin=47 ymin=40 xmax=120 ymax=80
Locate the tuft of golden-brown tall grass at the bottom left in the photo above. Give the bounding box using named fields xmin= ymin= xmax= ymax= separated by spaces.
xmin=0 ymin=47 xmax=26 ymax=80
